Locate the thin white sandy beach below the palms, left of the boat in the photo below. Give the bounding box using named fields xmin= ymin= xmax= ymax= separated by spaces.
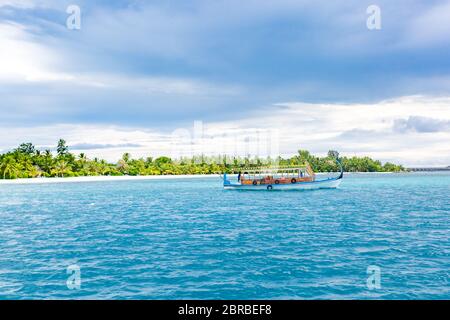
xmin=0 ymin=174 xmax=220 ymax=185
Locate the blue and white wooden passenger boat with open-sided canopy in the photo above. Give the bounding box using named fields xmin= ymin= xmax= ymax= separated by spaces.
xmin=222 ymin=161 xmax=344 ymax=190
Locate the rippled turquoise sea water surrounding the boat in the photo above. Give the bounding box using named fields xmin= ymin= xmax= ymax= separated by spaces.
xmin=0 ymin=173 xmax=450 ymax=299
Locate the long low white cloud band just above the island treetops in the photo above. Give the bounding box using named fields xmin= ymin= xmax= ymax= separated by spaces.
xmin=0 ymin=96 xmax=450 ymax=166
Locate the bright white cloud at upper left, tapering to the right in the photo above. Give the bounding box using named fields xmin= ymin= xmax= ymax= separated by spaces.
xmin=0 ymin=23 xmax=241 ymax=95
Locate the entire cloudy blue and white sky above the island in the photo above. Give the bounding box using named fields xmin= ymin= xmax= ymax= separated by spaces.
xmin=0 ymin=0 xmax=450 ymax=166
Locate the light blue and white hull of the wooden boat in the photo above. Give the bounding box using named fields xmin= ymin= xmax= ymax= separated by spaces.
xmin=223 ymin=178 xmax=342 ymax=190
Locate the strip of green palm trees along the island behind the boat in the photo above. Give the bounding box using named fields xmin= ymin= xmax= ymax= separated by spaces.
xmin=0 ymin=139 xmax=404 ymax=179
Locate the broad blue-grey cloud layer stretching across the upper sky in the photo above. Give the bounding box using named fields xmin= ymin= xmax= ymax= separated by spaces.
xmin=0 ymin=0 xmax=450 ymax=129
